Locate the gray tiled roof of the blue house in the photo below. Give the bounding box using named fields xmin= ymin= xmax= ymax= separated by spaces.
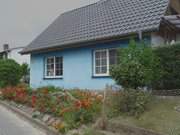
xmin=23 ymin=0 xmax=169 ymax=53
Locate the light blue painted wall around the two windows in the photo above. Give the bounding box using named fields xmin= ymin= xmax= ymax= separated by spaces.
xmin=30 ymin=37 xmax=150 ymax=89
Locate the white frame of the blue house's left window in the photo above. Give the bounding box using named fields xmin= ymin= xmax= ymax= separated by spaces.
xmin=44 ymin=56 xmax=63 ymax=79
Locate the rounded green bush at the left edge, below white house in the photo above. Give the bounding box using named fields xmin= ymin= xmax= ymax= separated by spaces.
xmin=0 ymin=59 xmax=22 ymax=87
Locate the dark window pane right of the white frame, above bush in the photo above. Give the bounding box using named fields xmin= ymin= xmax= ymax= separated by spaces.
xmin=109 ymin=49 xmax=118 ymax=65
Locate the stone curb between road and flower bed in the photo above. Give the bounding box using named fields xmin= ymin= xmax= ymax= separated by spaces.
xmin=0 ymin=100 xmax=61 ymax=135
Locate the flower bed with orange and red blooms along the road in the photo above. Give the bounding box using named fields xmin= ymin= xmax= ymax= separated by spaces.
xmin=1 ymin=85 xmax=103 ymax=132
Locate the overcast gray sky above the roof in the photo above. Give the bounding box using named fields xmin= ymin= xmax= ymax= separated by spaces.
xmin=0 ymin=0 xmax=98 ymax=48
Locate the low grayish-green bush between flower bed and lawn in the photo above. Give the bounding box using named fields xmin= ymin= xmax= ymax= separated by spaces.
xmin=119 ymin=89 xmax=151 ymax=117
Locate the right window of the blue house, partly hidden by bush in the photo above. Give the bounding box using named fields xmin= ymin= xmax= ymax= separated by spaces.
xmin=94 ymin=49 xmax=117 ymax=76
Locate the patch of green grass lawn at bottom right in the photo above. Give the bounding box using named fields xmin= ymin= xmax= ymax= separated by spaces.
xmin=112 ymin=98 xmax=180 ymax=135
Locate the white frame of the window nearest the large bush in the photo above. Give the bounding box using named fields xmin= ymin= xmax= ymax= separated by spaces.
xmin=93 ymin=49 xmax=110 ymax=77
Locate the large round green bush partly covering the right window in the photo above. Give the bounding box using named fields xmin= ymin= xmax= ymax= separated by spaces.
xmin=110 ymin=40 xmax=162 ymax=89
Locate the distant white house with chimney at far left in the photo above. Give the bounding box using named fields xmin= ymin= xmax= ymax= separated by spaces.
xmin=0 ymin=44 xmax=30 ymax=64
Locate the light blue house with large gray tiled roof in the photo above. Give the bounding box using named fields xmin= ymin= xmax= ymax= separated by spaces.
xmin=21 ymin=0 xmax=180 ymax=89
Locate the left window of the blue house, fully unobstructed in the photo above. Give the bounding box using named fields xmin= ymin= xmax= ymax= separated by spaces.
xmin=45 ymin=57 xmax=63 ymax=78
